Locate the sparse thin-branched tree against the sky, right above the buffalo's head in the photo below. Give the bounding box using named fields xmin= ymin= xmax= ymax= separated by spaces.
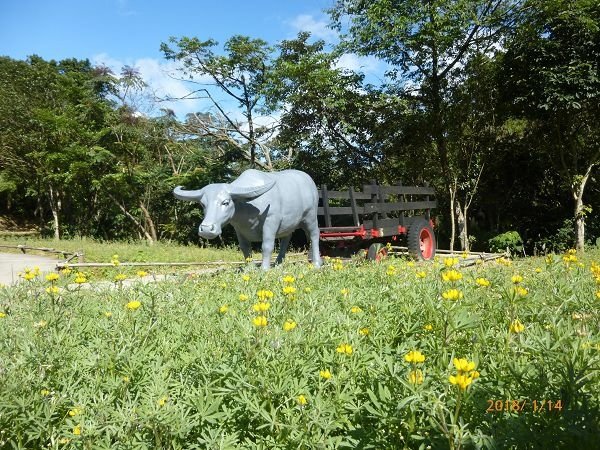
xmin=161 ymin=36 xmax=276 ymax=169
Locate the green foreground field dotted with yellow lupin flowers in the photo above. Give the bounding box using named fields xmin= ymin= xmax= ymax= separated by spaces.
xmin=0 ymin=247 xmax=600 ymax=449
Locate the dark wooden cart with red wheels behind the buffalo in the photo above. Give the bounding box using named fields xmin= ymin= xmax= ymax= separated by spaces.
xmin=318 ymin=181 xmax=437 ymax=261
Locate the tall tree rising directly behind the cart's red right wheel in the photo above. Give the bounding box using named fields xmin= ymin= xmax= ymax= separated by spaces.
xmin=330 ymin=0 xmax=522 ymax=250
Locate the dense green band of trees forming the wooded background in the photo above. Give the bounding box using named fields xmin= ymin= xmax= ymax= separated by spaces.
xmin=0 ymin=0 xmax=600 ymax=254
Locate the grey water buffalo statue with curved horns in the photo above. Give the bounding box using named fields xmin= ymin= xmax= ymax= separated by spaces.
xmin=173 ymin=169 xmax=322 ymax=270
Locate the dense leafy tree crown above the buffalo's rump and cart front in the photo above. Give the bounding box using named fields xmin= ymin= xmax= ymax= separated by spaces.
xmin=265 ymin=33 xmax=384 ymax=184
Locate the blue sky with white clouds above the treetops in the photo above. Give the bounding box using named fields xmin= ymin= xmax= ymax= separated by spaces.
xmin=0 ymin=0 xmax=379 ymax=115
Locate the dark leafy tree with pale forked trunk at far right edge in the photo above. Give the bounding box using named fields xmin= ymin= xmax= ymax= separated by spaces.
xmin=503 ymin=0 xmax=600 ymax=251
